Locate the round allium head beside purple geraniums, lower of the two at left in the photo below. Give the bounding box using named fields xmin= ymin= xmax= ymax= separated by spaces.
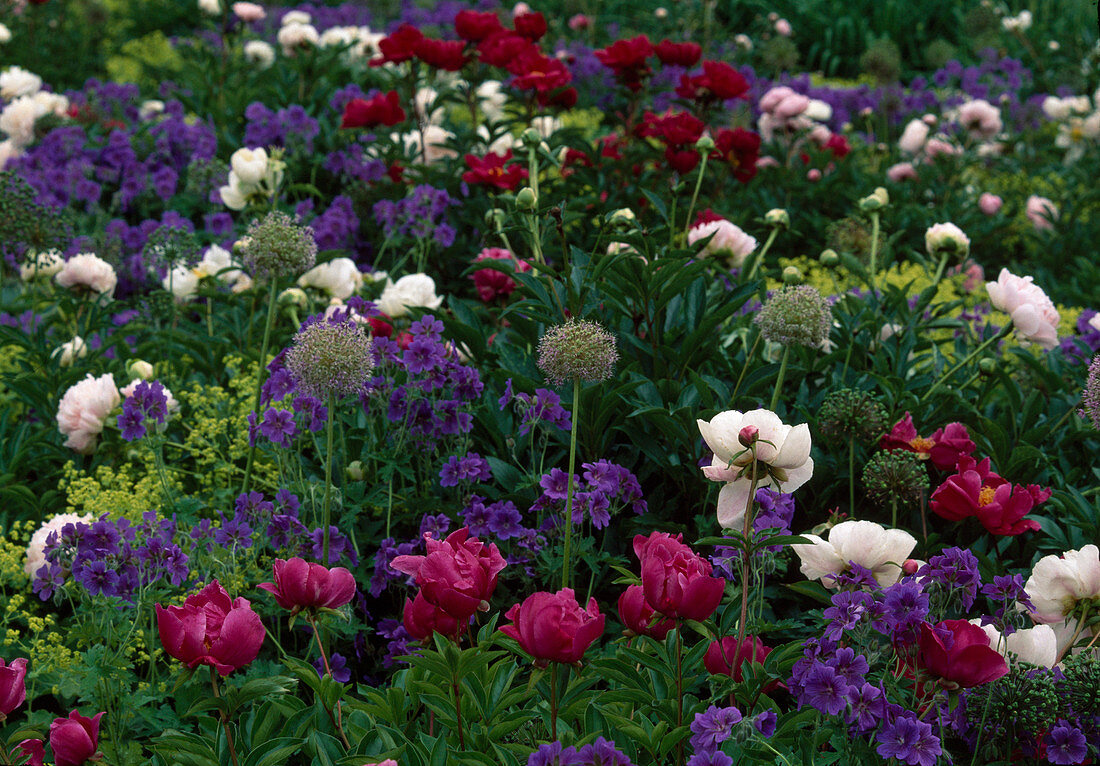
xmin=286 ymin=321 xmax=374 ymax=398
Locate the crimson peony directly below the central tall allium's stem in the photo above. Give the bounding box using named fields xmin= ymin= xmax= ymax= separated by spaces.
xmin=501 ymin=588 xmax=605 ymax=667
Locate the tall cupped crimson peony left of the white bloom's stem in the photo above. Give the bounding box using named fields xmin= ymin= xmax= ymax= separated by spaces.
xmin=634 ymin=532 xmax=726 ymax=621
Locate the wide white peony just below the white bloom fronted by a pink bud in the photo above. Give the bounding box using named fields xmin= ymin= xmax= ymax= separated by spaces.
xmin=791 ymin=522 xmax=916 ymax=588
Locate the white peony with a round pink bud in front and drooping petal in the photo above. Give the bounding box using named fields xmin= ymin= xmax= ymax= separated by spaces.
xmin=695 ymin=409 xmax=814 ymax=529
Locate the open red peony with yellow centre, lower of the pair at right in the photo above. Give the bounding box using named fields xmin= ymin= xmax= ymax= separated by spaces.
xmin=930 ymin=456 xmax=1051 ymax=535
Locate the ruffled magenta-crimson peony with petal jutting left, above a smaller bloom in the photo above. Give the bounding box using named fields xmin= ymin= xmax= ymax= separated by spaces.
xmin=389 ymin=527 xmax=505 ymax=622
